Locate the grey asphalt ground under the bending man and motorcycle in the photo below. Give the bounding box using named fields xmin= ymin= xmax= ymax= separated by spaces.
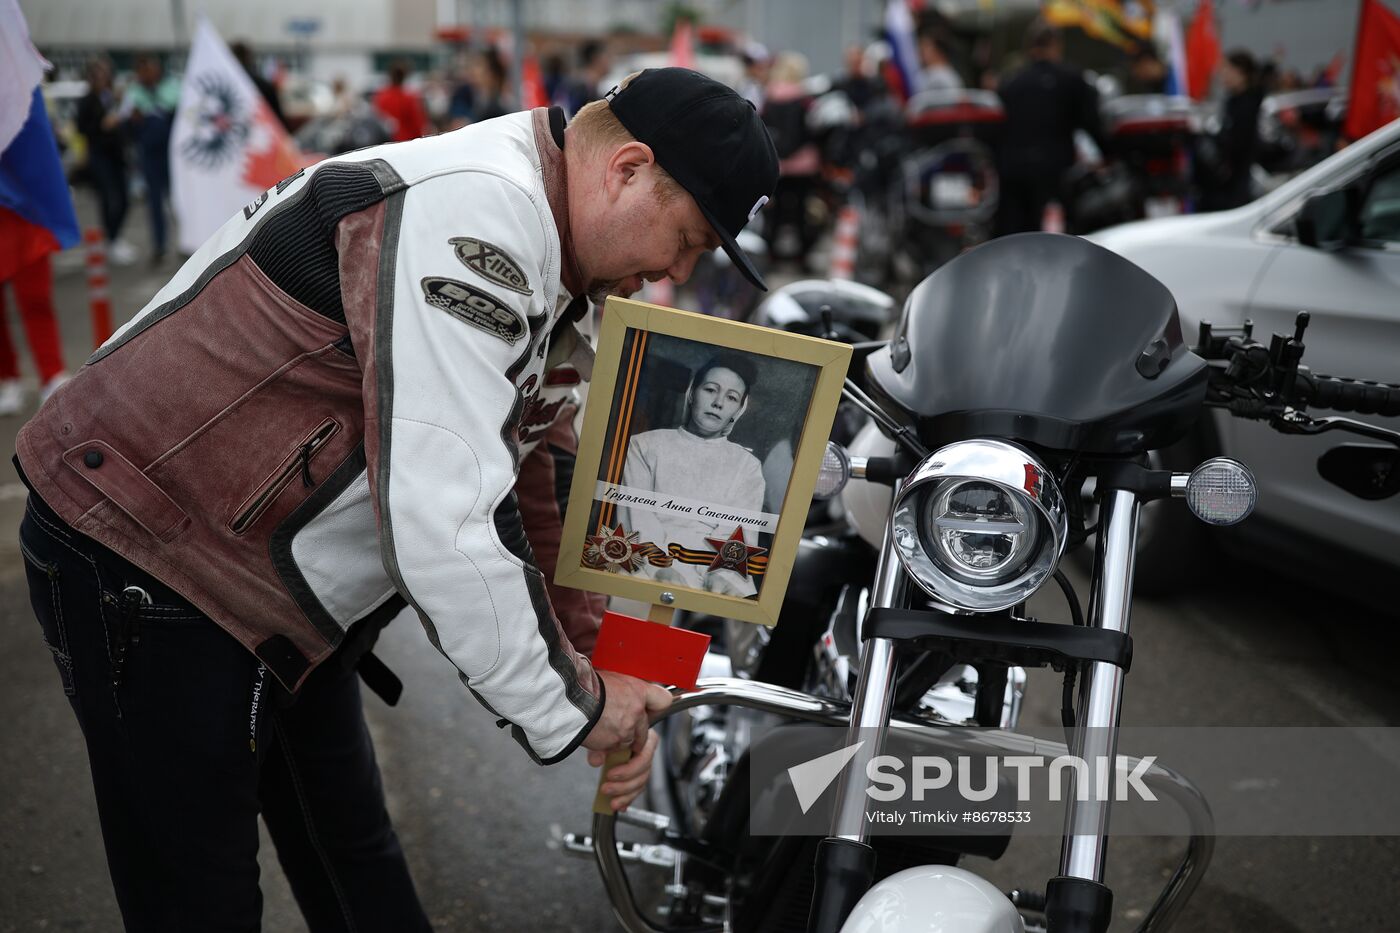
xmin=0 ymin=191 xmax=1400 ymax=933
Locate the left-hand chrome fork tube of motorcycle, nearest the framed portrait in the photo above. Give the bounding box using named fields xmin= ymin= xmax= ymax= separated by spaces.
xmin=832 ymin=524 xmax=909 ymax=843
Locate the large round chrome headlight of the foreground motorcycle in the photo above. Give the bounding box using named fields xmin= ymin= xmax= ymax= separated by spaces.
xmin=893 ymin=440 xmax=1068 ymax=612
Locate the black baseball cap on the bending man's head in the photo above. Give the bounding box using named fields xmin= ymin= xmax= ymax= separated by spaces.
xmin=606 ymin=69 xmax=778 ymax=291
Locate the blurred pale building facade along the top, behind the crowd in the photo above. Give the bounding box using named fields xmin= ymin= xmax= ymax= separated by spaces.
xmin=20 ymin=0 xmax=1377 ymax=103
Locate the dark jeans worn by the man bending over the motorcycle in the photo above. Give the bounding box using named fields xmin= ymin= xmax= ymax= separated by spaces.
xmin=20 ymin=495 xmax=430 ymax=933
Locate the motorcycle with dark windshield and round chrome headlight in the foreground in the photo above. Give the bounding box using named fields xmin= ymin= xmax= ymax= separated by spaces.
xmin=566 ymin=234 xmax=1400 ymax=933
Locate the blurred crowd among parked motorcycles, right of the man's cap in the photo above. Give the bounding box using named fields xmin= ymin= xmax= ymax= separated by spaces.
xmin=743 ymin=14 xmax=1337 ymax=272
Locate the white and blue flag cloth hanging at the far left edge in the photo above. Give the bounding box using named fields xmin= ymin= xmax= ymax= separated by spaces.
xmin=0 ymin=0 xmax=80 ymax=248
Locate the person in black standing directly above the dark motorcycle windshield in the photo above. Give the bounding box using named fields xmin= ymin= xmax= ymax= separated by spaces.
xmin=995 ymin=20 xmax=1102 ymax=237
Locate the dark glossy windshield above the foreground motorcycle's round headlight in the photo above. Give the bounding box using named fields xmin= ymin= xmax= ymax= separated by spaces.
xmin=868 ymin=233 xmax=1207 ymax=454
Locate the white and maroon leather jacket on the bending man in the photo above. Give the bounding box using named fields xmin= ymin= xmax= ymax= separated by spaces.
xmin=17 ymin=109 xmax=602 ymax=763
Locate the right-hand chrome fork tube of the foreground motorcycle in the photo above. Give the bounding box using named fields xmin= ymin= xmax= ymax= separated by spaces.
xmin=1060 ymin=489 xmax=1140 ymax=883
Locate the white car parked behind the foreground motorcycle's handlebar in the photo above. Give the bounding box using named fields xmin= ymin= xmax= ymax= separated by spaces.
xmin=1089 ymin=120 xmax=1400 ymax=595
